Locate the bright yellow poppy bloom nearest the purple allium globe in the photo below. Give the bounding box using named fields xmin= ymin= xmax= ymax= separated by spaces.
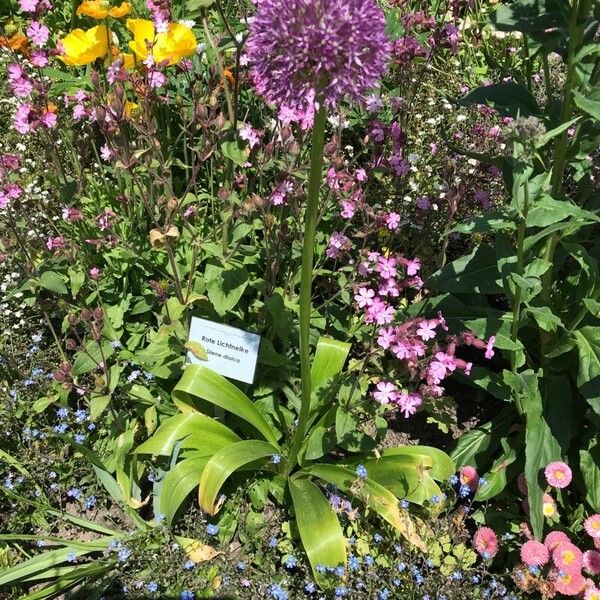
xmin=127 ymin=19 xmax=198 ymax=65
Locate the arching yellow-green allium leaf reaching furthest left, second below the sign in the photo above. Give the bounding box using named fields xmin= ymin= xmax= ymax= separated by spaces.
xmin=135 ymin=413 xmax=240 ymax=456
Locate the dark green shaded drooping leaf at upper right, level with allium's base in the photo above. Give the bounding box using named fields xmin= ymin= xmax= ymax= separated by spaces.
xmin=458 ymin=81 xmax=541 ymax=118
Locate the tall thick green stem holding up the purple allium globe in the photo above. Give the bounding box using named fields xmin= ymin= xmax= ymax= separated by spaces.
xmin=287 ymin=106 xmax=327 ymax=474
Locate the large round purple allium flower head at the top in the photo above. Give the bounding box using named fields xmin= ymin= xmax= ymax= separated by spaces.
xmin=247 ymin=0 xmax=390 ymax=120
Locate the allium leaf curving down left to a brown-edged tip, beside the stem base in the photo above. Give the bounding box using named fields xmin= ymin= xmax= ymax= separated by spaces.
xmin=198 ymin=440 xmax=279 ymax=515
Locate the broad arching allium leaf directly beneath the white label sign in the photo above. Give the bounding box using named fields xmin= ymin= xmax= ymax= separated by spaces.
xmin=173 ymin=365 xmax=278 ymax=445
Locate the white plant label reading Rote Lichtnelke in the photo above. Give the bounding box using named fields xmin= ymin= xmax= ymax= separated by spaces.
xmin=188 ymin=317 xmax=260 ymax=383
